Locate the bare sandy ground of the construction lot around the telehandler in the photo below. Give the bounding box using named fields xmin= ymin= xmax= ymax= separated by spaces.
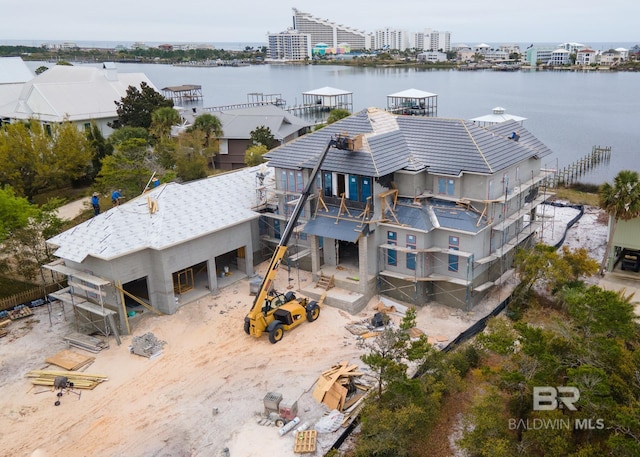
xmin=0 ymin=204 xmax=616 ymax=457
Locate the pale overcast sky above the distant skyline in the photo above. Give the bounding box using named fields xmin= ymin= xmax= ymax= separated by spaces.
xmin=0 ymin=0 xmax=640 ymax=45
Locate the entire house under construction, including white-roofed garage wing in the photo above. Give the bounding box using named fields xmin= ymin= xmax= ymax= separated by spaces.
xmin=47 ymin=108 xmax=551 ymax=334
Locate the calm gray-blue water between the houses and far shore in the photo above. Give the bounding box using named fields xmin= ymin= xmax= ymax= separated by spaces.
xmin=29 ymin=62 xmax=640 ymax=183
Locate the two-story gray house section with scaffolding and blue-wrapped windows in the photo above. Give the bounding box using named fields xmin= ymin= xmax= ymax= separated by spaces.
xmin=267 ymin=108 xmax=551 ymax=310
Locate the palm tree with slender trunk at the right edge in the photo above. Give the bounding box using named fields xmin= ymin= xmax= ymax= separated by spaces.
xmin=599 ymin=170 xmax=640 ymax=275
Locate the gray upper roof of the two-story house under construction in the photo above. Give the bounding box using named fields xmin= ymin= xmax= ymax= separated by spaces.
xmin=267 ymin=108 xmax=551 ymax=177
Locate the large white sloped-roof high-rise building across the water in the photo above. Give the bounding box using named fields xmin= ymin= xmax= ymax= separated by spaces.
xmin=292 ymin=8 xmax=374 ymax=49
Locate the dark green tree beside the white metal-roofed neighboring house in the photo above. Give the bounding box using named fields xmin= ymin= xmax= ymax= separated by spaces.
xmin=110 ymin=81 xmax=173 ymax=130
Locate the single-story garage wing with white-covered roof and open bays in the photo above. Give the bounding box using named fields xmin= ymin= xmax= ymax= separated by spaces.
xmin=47 ymin=166 xmax=273 ymax=333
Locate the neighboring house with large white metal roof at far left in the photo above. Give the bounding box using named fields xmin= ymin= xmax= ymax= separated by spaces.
xmin=0 ymin=62 xmax=155 ymax=136
